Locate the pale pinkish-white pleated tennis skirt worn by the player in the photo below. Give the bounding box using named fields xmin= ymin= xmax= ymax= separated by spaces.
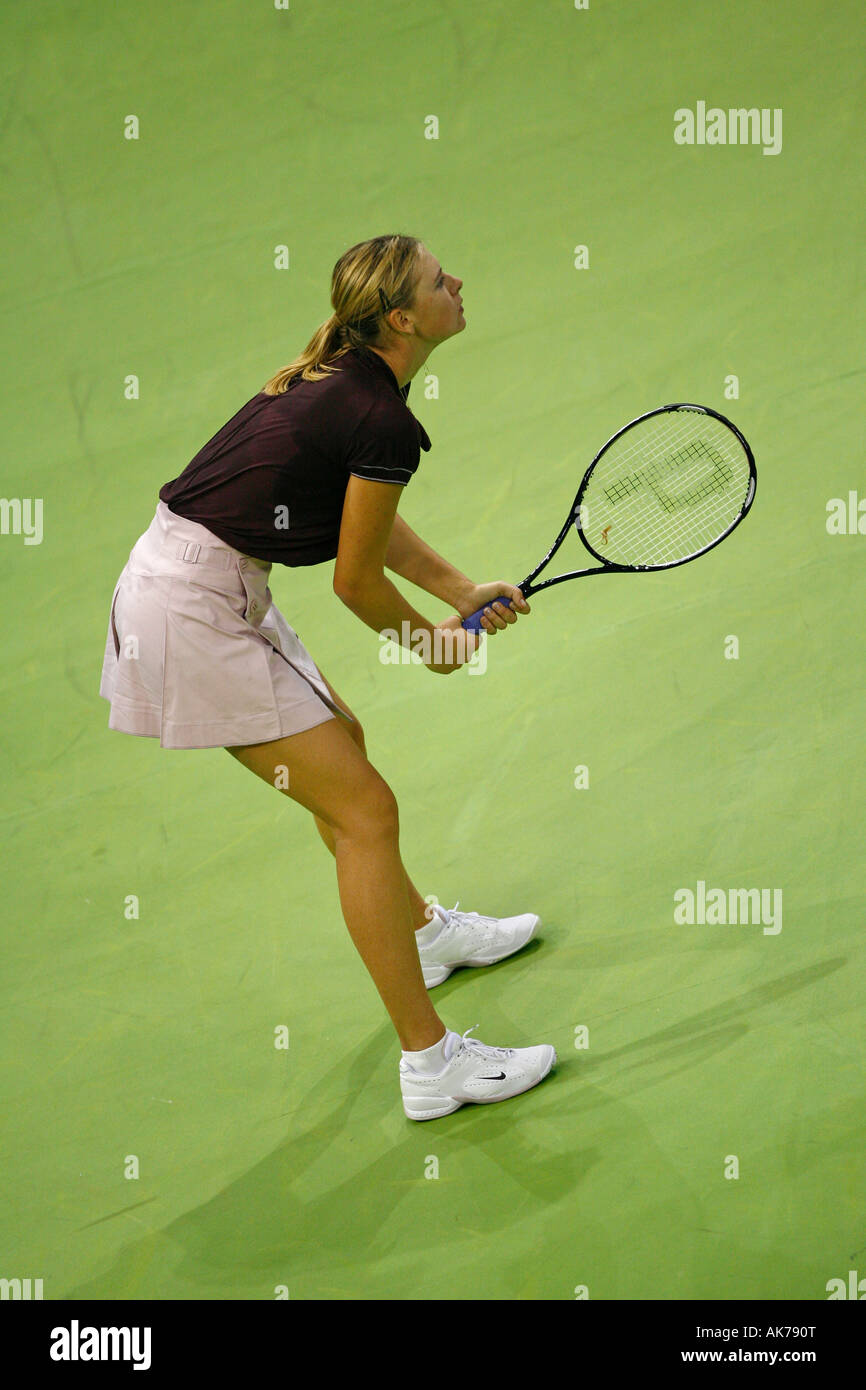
xmin=99 ymin=502 xmax=348 ymax=748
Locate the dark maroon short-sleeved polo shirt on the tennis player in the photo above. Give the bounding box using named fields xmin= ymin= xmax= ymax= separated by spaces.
xmin=160 ymin=349 xmax=430 ymax=566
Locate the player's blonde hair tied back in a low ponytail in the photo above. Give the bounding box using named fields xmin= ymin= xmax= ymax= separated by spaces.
xmin=261 ymin=236 xmax=421 ymax=396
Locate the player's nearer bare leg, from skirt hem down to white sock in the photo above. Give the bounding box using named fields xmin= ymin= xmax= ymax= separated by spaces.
xmin=228 ymin=719 xmax=446 ymax=1052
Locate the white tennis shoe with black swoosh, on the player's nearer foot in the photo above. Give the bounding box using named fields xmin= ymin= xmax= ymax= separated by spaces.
xmin=400 ymin=1023 xmax=556 ymax=1120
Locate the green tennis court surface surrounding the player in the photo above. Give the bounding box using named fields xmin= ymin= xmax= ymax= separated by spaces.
xmin=0 ymin=0 xmax=866 ymax=1301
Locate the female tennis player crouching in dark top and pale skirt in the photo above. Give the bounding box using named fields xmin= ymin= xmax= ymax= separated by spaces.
xmin=100 ymin=236 xmax=556 ymax=1120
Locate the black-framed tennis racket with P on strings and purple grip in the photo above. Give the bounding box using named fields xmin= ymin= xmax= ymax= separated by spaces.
xmin=463 ymin=404 xmax=758 ymax=632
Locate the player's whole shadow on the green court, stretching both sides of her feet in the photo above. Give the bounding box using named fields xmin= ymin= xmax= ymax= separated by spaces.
xmin=64 ymin=958 xmax=845 ymax=1298
